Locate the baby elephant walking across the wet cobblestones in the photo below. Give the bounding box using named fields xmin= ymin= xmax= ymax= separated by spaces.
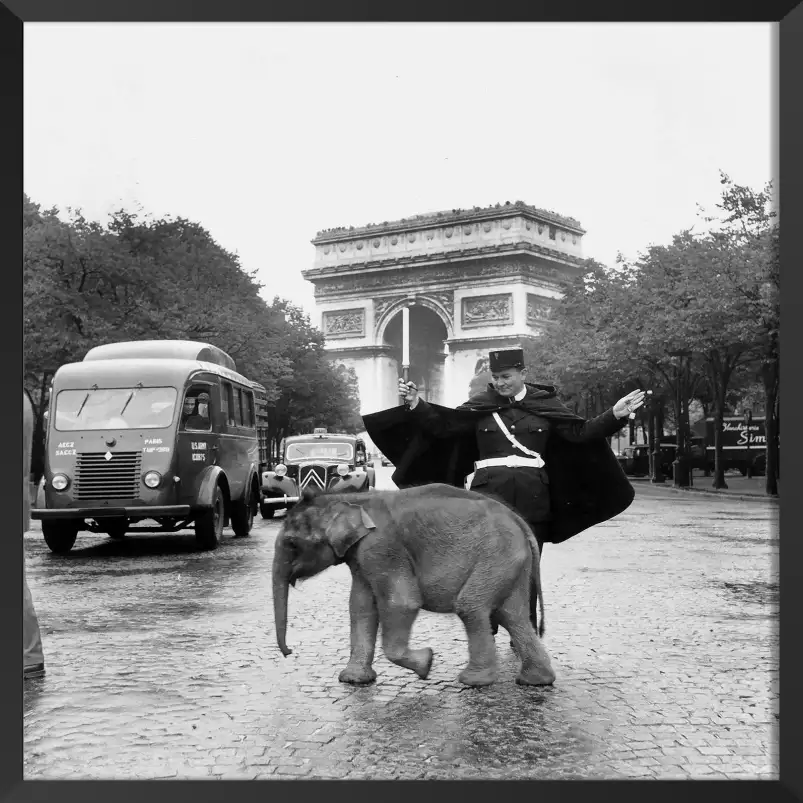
xmin=273 ymin=484 xmax=555 ymax=686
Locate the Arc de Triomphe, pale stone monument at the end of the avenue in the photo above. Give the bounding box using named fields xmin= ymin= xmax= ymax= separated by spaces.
xmin=303 ymin=202 xmax=585 ymax=415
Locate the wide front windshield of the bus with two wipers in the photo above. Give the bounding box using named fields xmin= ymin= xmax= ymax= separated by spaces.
xmin=56 ymin=388 xmax=178 ymax=432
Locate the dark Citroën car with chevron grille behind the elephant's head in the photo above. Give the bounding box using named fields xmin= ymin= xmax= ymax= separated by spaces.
xmin=259 ymin=428 xmax=376 ymax=519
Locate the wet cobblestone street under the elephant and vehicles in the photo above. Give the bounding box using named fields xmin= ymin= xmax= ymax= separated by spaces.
xmin=24 ymin=469 xmax=779 ymax=780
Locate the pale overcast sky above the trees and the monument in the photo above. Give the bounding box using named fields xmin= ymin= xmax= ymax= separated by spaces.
xmin=24 ymin=23 xmax=775 ymax=321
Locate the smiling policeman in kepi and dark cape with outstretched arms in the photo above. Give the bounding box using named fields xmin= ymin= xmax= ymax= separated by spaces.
xmin=363 ymin=349 xmax=644 ymax=547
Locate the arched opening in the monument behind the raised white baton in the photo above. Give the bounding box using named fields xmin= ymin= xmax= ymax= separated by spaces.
xmin=381 ymin=303 xmax=449 ymax=404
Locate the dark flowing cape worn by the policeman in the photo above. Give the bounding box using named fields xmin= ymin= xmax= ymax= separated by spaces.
xmin=363 ymin=383 xmax=635 ymax=544
